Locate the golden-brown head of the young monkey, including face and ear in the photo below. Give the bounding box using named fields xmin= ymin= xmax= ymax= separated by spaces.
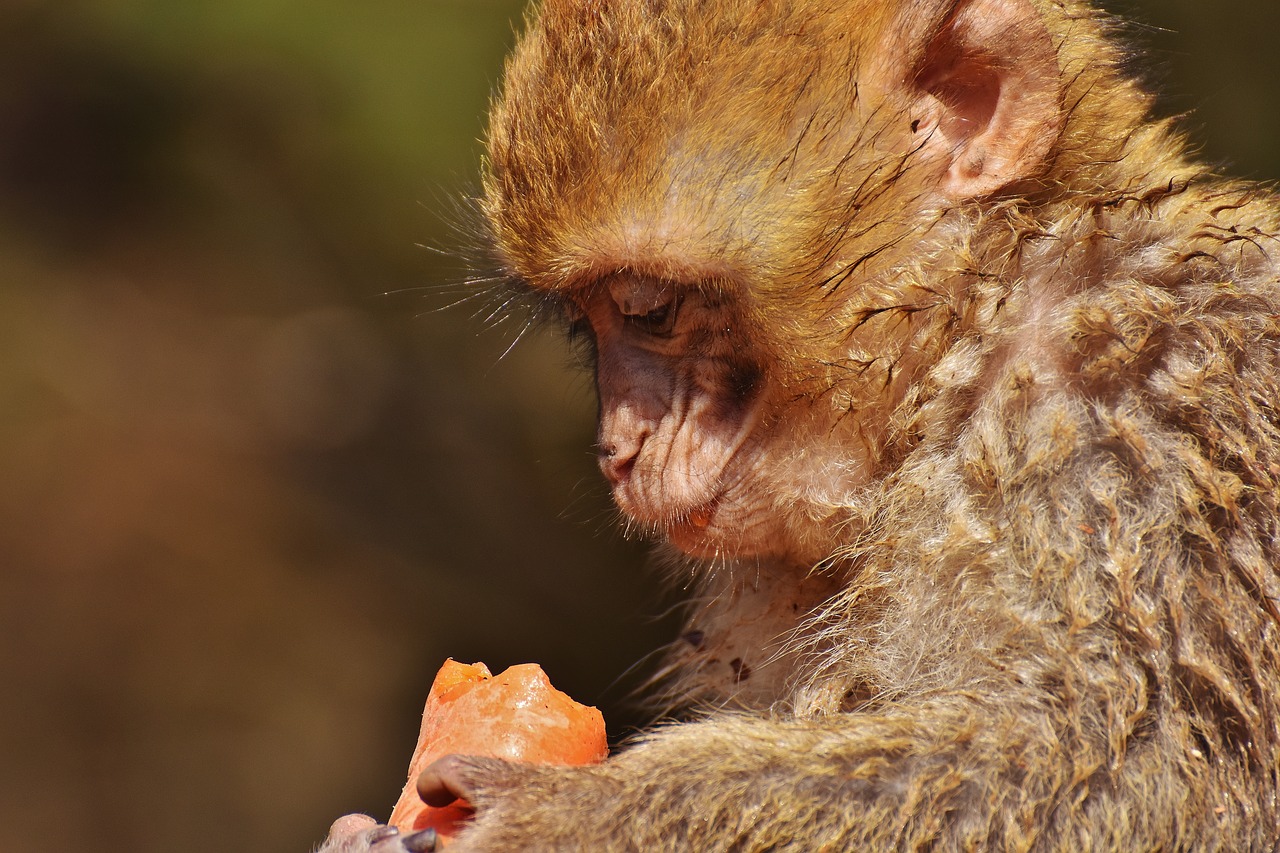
xmin=483 ymin=0 xmax=1105 ymax=562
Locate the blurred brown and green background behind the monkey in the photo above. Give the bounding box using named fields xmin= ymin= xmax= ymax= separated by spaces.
xmin=0 ymin=0 xmax=1280 ymax=853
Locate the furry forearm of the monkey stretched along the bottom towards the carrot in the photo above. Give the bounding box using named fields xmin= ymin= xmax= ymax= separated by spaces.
xmin=424 ymin=693 xmax=1178 ymax=853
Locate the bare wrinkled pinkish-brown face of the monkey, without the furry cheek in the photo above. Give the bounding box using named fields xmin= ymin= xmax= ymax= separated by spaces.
xmin=579 ymin=272 xmax=765 ymax=553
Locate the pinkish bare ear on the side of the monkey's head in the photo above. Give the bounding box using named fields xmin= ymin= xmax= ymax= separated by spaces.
xmin=899 ymin=0 xmax=1064 ymax=199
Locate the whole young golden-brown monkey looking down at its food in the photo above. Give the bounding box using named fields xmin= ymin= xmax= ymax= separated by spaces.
xmin=325 ymin=0 xmax=1280 ymax=853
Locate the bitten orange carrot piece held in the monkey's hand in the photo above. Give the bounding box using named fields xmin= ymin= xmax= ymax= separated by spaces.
xmin=387 ymin=658 xmax=608 ymax=840
